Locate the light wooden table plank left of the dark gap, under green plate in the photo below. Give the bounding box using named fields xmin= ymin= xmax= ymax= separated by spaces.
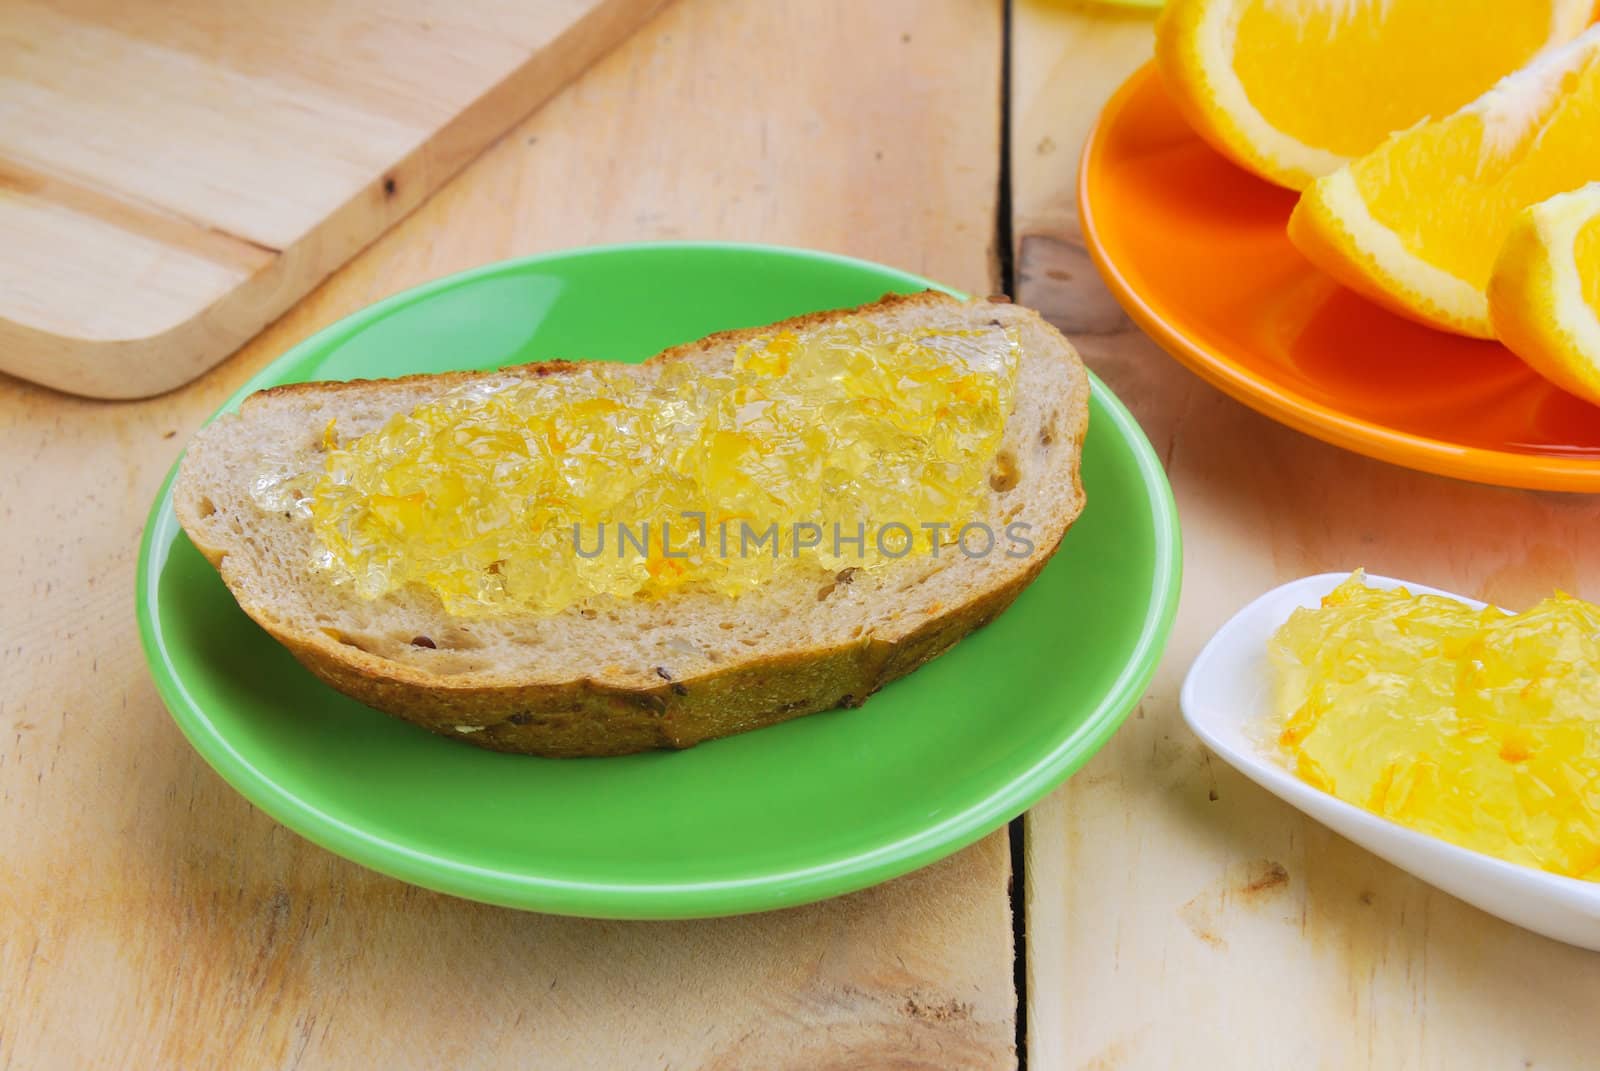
xmin=0 ymin=0 xmax=1014 ymax=1069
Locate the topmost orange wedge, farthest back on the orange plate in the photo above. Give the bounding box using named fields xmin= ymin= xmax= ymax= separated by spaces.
xmin=1155 ymin=0 xmax=1597 ymax=189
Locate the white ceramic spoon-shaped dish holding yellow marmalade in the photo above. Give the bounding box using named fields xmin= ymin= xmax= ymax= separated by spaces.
xmin=1179 ymin=573 xmax=1600 ymax=951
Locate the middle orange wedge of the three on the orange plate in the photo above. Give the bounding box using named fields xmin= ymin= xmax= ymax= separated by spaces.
xmin=1290 ymin=26 xmax=1600 ymax=338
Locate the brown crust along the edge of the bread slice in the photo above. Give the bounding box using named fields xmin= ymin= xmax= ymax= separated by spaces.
xmin=174 ymin=291 xmax=1088 ymax=757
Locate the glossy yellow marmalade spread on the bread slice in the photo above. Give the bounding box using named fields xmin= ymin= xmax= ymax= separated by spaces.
xmin=254 ymin=317 xmax=1018 ymax=616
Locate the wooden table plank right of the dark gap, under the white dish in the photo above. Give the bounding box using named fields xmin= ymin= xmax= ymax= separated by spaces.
xmin=1011 ymin=0 xmax=1600 ymax=1068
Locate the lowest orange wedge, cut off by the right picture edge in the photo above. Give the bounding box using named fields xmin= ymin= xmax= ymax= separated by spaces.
xmin=1490 ymin=183 xmax=1600 ymax=405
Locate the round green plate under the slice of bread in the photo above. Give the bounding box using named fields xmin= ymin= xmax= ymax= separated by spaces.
xmin=138 ymin=243 xmax=1179 ymax=919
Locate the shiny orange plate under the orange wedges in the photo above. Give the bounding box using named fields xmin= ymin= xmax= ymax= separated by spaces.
xmin=1078 ymin=64 xmax=1600 ymax=491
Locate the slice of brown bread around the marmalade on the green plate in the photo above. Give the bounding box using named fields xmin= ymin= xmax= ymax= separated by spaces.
xmin=173 ymin=291 xmax=1088 ymax=756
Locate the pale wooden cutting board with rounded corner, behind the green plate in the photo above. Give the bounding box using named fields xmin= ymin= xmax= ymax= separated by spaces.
xmin=0 ymin=0 xmax=664 ymax=399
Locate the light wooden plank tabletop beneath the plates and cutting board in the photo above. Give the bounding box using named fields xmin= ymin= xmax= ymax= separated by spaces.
xmin=9 ymin=0 xmax=1600 ymax=1068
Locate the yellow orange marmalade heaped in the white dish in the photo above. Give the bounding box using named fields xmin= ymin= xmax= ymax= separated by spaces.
xmin=1272 ymin=573 xmax=1600 ymax=880
